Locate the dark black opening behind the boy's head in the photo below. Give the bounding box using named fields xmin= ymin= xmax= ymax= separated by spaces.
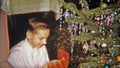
xmin=8 ymin=11 xmax=58 ymax=59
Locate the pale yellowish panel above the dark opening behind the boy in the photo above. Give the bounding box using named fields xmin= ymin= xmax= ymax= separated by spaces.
xmin=1 ymin=0 xmax=60 ymax=18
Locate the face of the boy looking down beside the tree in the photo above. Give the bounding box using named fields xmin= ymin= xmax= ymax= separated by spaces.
xmin=29 ymin=29 xmax=50 ymax=48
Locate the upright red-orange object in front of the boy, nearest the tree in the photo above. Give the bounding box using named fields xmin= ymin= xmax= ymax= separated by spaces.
xmin=57 ymin=48 xmax=69 ymax=68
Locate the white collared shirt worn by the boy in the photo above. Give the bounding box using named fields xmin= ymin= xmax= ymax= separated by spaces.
xmin=8 ymin=39 xmax=49 ymax=68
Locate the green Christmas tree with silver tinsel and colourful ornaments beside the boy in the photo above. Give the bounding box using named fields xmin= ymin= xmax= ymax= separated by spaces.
xmin=58 ymin=0 xmax=120 ymax=68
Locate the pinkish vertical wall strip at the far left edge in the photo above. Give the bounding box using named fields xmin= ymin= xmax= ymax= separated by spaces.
xmin=0 ymin=10 xmax=9 ymax=68
